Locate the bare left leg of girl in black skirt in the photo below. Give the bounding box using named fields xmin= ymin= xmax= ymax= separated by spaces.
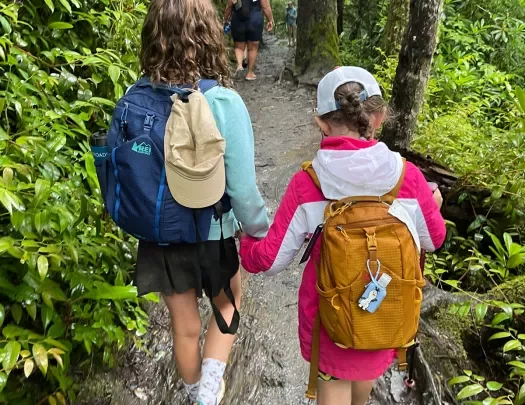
xmin=163 ymin=289 xmax=202 ymax=384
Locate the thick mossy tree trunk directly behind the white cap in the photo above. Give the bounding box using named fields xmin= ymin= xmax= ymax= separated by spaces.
xmin=295 ymin=0 xmax=340 ymax=84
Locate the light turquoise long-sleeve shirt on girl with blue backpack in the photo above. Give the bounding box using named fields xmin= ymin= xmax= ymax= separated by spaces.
xmin=205 ymin=86 xmax=269 ymax=240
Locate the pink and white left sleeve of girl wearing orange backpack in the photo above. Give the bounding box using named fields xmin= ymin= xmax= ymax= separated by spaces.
xmin=239 ymin=176 xmax=308 ymax=275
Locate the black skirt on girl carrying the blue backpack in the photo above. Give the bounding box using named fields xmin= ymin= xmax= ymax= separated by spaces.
xmin=134 ymin=238 xmax=239 ymax=298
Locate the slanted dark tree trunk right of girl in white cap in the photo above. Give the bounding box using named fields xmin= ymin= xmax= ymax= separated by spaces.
xmin=382 ymin=0 xmax=442 ymax=148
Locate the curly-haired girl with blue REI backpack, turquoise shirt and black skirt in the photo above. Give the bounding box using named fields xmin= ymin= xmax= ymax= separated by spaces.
xmin=121 ymin=0 xmax=269 ymax=405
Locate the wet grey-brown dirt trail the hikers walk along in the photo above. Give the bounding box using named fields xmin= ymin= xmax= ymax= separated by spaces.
xmin=77 ymin=36 xmax=414 ymax=405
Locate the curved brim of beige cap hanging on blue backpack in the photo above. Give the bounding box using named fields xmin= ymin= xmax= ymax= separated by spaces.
xmin=166 ymin=157 xmax=226 ymax=209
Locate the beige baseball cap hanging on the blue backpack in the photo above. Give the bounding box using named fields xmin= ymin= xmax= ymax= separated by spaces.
xmin=164 ymin=91 xmax=226 ymax=209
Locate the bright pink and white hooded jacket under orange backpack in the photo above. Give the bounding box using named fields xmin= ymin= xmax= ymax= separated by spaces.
xmin=240 ymin=137 xmax=446 ymax=381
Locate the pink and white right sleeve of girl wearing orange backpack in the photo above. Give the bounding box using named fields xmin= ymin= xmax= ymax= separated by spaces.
xmin=414 ymin=166 xmax=447 ymax=252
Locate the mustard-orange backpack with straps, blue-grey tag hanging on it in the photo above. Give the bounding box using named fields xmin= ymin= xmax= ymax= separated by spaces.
xmin=302 ymin=161 xmax=425 ymax=398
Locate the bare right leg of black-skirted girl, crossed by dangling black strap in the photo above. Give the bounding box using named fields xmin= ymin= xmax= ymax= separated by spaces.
xmin=204 ymin=271 xmax=241 ymax=363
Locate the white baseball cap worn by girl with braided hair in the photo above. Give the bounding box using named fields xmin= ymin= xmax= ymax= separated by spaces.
xmin=317 ymin=66 xmax=381 ymax=115
